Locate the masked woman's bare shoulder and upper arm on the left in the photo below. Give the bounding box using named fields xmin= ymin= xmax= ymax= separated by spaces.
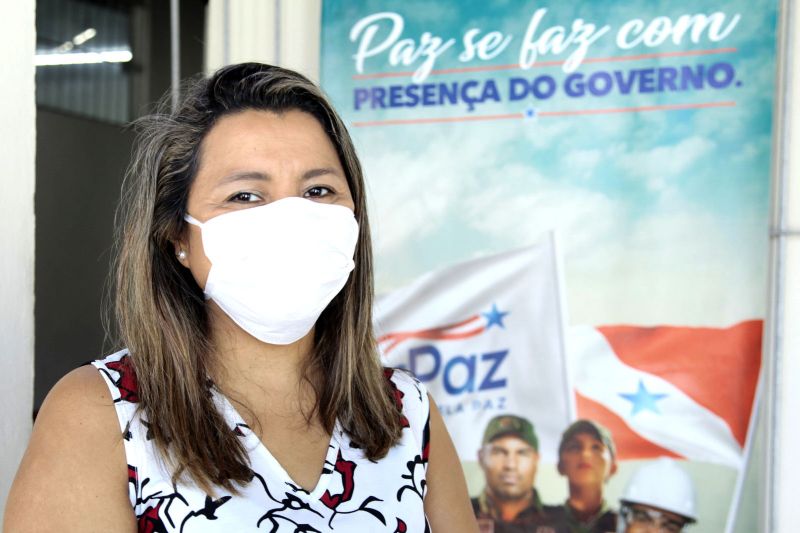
xmin=5 ymin=365 xmax=133 ymax=531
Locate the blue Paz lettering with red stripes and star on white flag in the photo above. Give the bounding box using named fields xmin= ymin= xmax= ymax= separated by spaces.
xmin=378 ymin=304 xmax=510 ymax=395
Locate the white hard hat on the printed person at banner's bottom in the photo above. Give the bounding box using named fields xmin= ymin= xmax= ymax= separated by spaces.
xmin=620 ymin=457 xmax=697 ymax=522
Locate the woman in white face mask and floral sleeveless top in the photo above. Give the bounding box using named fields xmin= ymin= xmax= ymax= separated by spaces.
xmin=4 ymin=63 xmax=477 ymax=533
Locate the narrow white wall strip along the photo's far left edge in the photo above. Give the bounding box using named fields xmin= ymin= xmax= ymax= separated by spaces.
xmin=0 ymin=0 xmax=36 ymax=522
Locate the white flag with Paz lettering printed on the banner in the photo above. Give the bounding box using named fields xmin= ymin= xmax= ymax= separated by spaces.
xmin=375 ymin=233 xmax=574 ymax=462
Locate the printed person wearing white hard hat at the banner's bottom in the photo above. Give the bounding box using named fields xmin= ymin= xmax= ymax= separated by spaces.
xmin=617 ymin=458 xmax=697 ymax=533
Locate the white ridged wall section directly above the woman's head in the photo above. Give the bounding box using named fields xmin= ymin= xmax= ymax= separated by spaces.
xmin=205 ymin=0 xmax=322 ymax=81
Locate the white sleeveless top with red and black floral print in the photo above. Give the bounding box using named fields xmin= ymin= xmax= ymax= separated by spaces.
xmin=92 ymin=350 xmax=430 ymax=533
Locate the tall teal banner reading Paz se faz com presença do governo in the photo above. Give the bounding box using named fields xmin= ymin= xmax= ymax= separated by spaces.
xmin=321 ymin=0 xmax=777 ymax=533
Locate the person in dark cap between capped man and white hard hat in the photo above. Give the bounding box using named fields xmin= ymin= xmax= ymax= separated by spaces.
xmin=550 ymin=420 xmax=617 ymax=533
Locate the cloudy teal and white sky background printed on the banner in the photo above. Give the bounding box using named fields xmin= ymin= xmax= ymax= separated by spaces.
xmin=322 ymin=0 xmax=775 ymax=325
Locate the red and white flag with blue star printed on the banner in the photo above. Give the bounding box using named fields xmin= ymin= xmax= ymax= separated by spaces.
xmin=568 ymin=320 xmax=762 ymax=468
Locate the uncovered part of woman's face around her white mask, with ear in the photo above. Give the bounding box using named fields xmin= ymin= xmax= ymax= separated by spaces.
xmin=181 ymin=110 xmax=354 ymax=287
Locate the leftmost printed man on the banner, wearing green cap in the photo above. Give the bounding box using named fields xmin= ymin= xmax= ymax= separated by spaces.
xmin=472 ymin=415 xmax=554 ymax=533
